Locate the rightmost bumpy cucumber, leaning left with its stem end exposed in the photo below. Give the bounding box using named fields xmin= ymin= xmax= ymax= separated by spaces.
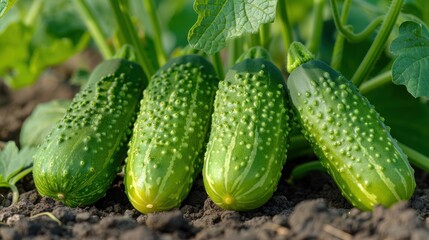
xmin=287 ymin=60 xmax=416 ymax=210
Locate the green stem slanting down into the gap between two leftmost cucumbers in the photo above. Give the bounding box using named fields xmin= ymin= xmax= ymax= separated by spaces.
xmin=110 ymin=0 xmax=155 ymax=79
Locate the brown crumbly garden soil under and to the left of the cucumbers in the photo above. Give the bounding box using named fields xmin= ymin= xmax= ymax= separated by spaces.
xmin=0 ymin=53 xmax=429 ymax=240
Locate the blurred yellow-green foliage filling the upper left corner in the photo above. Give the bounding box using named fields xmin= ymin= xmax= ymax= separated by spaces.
xmin=0 ymin=0 xmax=90 ymax=89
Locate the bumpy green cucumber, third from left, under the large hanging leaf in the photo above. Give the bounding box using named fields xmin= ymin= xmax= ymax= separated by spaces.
xmin=203 ymin=58 xmax=290 ymax=211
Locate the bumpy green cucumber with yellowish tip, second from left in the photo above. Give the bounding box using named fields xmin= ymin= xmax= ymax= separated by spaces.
xmin=125 ymin=55 xmax=218 ymax=213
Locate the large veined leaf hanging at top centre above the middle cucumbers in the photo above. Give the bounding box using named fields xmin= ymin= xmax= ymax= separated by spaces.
xmin=188 ymin=0 xmax=277 ymax=54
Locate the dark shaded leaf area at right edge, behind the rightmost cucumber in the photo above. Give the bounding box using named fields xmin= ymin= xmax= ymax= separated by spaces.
xmin=366 ymin=83 xmax=429 ymax=156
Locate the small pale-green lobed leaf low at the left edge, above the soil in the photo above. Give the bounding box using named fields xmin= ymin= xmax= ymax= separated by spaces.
xmin=0 ymin=141 xmax=36 ymax=204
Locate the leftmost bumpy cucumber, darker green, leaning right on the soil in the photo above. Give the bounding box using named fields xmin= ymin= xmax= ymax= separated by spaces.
xmin=33 ymin=59 xmax=147 ymax=207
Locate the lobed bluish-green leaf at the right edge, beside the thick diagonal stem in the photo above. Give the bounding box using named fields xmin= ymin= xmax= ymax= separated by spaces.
xmin=390 ymin=21 xmax=429 ymax=97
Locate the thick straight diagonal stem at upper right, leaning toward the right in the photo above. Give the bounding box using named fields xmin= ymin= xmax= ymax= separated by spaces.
xmin=351 ymin=0 xmax=404 ymax=86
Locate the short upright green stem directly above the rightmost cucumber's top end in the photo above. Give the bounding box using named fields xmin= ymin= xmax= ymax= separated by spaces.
xmin=307 ymin=0 xmax=326 ymax=54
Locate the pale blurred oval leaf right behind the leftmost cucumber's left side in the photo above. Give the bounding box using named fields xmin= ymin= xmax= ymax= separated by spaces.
xmin=19 ymin=100 xmax=71 ymax=147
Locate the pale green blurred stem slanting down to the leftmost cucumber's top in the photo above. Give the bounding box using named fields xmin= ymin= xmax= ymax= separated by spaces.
xmin=75 ymin=0 xmax=113 ymax=59
